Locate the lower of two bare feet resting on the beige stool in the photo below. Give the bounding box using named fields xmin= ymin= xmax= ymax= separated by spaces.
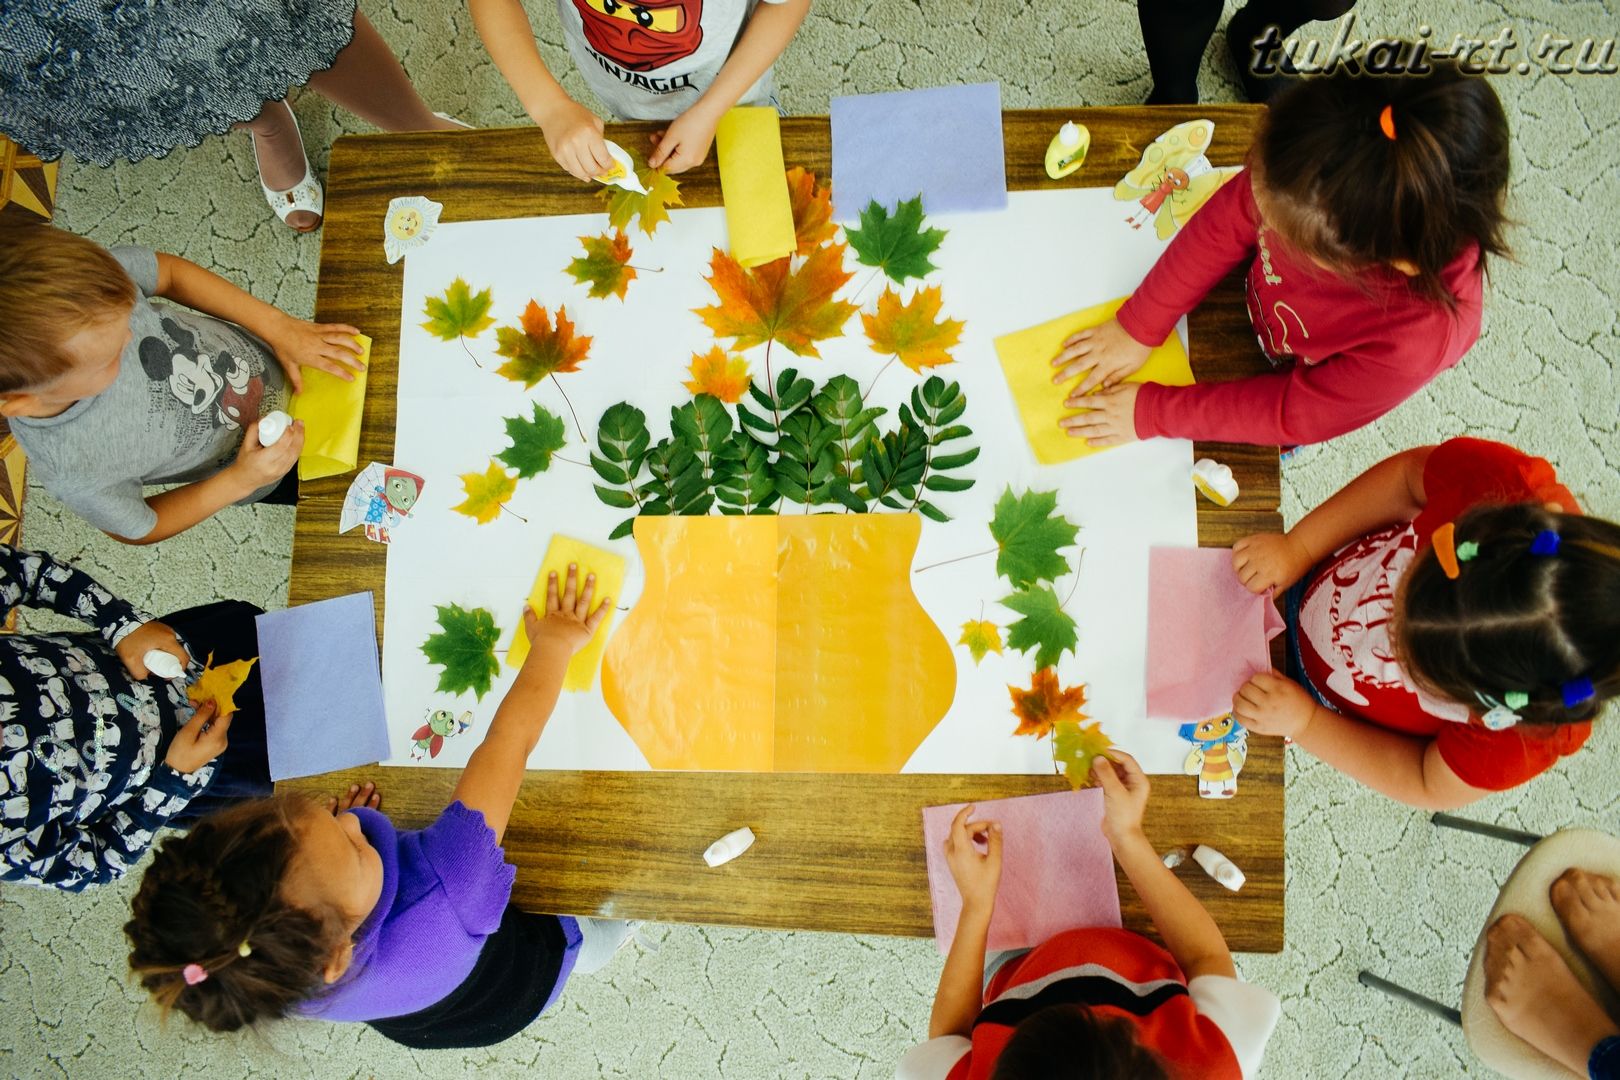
xmin=1486 ymin=915 xmax=1620 ymax=1077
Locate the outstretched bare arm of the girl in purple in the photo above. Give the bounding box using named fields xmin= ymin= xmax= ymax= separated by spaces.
xmin=450 ymin=563 xmax=612 ymax=844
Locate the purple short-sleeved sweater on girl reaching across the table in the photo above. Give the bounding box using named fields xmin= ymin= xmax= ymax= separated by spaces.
xmin=298 ymin=801 xmax=557 ymax=1020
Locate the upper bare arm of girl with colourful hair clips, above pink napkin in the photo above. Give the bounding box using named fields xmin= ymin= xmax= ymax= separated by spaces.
xmin=1231 ymin=447 xmax=1434 ymax=593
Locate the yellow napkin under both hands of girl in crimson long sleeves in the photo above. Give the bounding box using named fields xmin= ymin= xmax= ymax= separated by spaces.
xmin=996 ymin=296 xmax=1192 ymax=465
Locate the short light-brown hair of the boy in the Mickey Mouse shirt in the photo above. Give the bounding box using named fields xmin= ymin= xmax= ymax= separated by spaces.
xmin=0 ymin=220 xmax=134 ymax=393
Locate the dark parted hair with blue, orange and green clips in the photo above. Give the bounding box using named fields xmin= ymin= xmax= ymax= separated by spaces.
xmin=1395 ymin=502 xmax=1620 ymax=724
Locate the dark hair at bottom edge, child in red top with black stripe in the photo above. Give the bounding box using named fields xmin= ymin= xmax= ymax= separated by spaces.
xmin=990 ymin=1006 xmax=1170 ymax=1080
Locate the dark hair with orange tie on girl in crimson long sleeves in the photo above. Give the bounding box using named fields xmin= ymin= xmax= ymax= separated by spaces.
xmin=1249 ymin=60 xmax=1508 ymax=308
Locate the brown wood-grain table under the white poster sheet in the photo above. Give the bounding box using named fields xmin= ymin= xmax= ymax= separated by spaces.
xmin=282 ymin=105 xmax=1283 ymax=952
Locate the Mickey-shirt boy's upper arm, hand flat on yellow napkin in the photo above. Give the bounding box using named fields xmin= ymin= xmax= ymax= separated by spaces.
xmin=157 ymin=251 xmax=361 ymax=393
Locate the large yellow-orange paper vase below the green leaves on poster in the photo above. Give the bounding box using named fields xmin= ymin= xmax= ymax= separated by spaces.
xmin=603 ymin=513 xmax=956 ymax=772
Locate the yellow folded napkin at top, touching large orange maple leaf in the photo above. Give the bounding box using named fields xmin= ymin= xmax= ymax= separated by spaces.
xmin=714 ymin=105 xmax=799 ymax=266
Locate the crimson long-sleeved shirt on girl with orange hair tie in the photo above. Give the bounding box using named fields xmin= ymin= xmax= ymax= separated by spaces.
xmin=1118 ymin=172 xmax=1482 ymax=445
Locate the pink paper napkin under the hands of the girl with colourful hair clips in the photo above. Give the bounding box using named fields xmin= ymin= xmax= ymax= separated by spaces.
xmin=1147 ymin=547 xmax=1283 ymax=724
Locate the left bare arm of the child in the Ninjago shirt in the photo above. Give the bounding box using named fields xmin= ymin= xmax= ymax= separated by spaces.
xmin=467 ymin=0 xmax=614 ymax=180
